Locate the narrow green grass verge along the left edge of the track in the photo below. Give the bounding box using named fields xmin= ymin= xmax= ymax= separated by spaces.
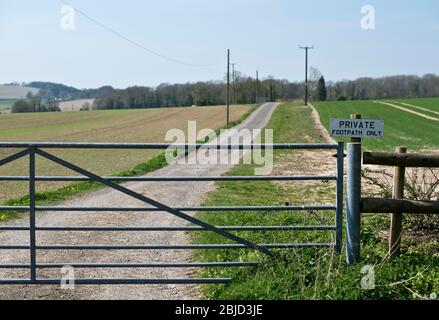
xmin=0 ymin=105 xmax=259 ymax=221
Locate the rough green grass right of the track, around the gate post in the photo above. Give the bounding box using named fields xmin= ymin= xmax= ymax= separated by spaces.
xmin=192 ymin=104 xmax=439 ymax=300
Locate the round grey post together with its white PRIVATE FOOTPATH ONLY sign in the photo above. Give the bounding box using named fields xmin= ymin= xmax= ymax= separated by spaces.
xmin=331 ymin=115 xmax=384 ymax=265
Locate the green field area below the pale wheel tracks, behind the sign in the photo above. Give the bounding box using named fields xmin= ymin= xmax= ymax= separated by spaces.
xmin=314 ymin=101 xmax=439 ymax=151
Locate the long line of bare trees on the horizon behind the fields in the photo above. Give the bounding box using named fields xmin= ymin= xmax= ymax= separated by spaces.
xmin=94 ymin=69 xmax=439 ymax=109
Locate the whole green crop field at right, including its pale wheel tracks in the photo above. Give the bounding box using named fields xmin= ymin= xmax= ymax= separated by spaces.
xmin=314 ymin=98 xmax=439 ymax=151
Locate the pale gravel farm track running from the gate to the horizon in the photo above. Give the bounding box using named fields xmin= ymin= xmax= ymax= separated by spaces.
xmin=0 ymin=103 xmax=277 ymax=300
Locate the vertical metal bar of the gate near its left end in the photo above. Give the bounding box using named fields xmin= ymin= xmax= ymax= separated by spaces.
xmin=29 ymin=146 xmax=37 ymax=283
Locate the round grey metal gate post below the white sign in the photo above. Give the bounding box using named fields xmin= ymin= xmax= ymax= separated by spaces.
xmin=346 ymin=143 xmax=361 ymax=265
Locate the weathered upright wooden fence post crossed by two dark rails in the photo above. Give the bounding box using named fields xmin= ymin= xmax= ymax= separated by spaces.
xmin=389 ymin=147 xmax=407 ymax=258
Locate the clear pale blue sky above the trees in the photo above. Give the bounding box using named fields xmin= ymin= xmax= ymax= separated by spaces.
xmin=0 ymin=0 xmax=439 ymax=88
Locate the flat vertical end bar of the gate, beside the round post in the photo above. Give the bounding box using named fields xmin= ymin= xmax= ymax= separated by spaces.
xmin=335 ymin=142 xmax=344 ymax=255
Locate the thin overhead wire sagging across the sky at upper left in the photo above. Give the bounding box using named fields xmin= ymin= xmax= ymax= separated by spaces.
xmin=59 ymin=0 xmax=221 ymax=68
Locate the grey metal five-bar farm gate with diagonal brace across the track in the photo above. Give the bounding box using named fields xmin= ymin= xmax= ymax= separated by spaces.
xmin=0 ymin=142 xmax=344 ymax=285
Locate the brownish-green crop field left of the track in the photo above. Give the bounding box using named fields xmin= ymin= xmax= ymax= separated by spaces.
xmin=0 ymin=105 xmax=251 ymax=203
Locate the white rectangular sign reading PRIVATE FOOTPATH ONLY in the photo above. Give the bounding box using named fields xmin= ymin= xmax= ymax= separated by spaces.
xmin=331 ymin=119 xmax=384 ymax=139
